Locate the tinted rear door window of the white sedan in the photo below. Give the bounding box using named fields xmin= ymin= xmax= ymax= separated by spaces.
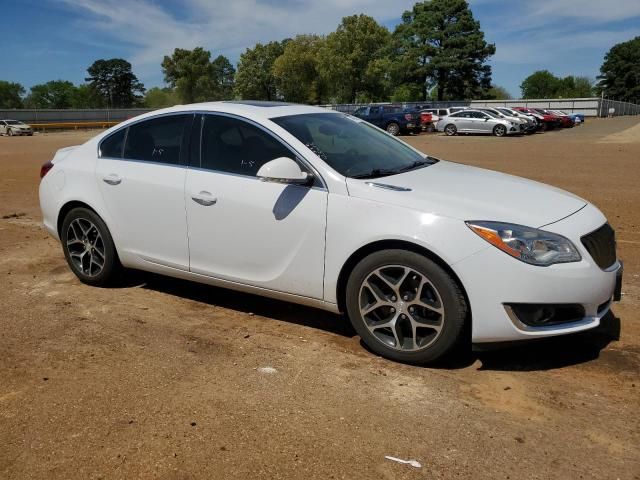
xmin=124 ymin=115 xmax=189 ymax=165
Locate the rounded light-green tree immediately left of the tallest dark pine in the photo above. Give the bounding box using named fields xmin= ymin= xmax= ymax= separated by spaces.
xmin=318 ymin=15 xmax=391 ymax=102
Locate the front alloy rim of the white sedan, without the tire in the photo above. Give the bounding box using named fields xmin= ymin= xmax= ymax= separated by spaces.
xmin=359 ymin=265 xmax=445 ymax=352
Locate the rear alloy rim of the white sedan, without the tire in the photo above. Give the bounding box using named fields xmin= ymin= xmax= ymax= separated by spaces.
xmin=67 ymin=218 xmax=106 ymax=277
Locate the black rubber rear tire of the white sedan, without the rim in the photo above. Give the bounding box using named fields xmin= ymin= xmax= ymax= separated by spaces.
xmin=60 ymin=207 xmax=122 ymax=287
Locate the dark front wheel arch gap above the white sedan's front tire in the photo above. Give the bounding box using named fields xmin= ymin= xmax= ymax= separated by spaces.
xmin=336 ymin=240 xmax=471 ymax=318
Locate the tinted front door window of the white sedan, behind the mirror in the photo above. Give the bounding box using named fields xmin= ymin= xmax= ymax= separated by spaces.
xmin=201 ymin=115 xmax=295 ymax=176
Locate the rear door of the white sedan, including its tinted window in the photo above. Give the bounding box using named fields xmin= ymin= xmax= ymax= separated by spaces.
xmin=96 ymin=114 xmax=193 ymax=270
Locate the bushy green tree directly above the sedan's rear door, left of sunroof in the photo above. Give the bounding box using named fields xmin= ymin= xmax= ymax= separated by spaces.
xmin=162 ymin=47 xmax=235 ymax=103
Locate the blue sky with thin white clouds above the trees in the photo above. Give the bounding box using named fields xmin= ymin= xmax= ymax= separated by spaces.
xmin=0 ymin=0 xmax=640 ymax=97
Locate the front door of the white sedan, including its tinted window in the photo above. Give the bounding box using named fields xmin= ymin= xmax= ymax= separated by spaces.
xmin=185 ymin=114 xmax=327 ymax=299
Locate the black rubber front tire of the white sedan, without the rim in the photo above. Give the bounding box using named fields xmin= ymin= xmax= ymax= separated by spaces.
xmin=345 ymin=249 xmax=468 ymax=365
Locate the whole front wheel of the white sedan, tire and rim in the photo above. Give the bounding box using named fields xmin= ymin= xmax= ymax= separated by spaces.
xmin=346 ymin=250 xmax=468 ymax=364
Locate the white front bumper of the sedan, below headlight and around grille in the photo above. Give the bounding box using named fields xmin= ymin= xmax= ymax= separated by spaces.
xmin=453 ymin=205 xmax=621 ymax=343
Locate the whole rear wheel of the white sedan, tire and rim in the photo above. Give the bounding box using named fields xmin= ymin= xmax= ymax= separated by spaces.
xmin=60 ymin=208 xmax=121 ymax=286
